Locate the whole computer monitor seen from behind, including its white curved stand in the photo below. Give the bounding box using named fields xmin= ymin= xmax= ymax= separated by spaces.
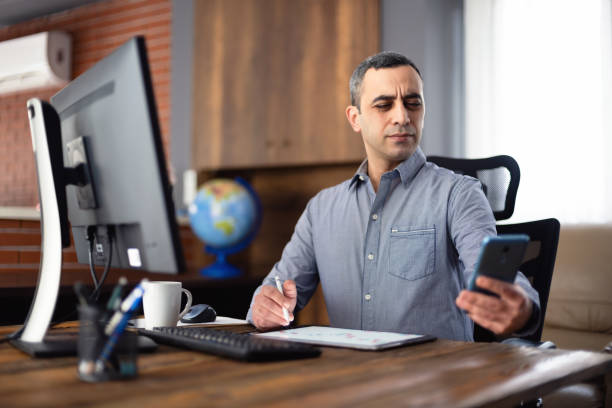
xmin=11 ymin=37 xmax=185 ymax=355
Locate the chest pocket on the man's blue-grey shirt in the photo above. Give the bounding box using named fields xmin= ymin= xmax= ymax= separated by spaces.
xmin=389 ymin=227 xmax=436 ymax=280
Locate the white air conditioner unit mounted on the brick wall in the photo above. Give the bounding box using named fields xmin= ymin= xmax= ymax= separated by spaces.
xmin=0 ymin=31 xmax=72 ymax=94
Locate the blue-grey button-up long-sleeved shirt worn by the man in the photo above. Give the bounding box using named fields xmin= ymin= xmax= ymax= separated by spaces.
xmin=247 ymin=148 xmax=539 ymax=341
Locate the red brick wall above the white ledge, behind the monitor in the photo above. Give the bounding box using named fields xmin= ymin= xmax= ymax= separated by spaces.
xmin=0 ymin=0 xmax=172 ymax=206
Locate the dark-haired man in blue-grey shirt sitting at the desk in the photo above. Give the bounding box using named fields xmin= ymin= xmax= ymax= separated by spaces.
xmin=247 ymin=52 xmax=539 ymax=341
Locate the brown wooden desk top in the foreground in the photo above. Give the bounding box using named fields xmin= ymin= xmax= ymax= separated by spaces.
xmin=0 ymin=327 xmax=612 ymax=408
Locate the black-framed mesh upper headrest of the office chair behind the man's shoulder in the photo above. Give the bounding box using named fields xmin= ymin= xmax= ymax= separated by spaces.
xmin=427 ymin=155 xmax=521 ymax=221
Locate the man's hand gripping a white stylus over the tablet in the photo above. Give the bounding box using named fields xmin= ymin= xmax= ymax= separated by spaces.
xmin=252 ymin=280 xmax=297 ymax=330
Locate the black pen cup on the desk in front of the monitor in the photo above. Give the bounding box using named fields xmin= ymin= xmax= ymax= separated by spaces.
xmin=77 ymin=305 xmax=138 ymax=382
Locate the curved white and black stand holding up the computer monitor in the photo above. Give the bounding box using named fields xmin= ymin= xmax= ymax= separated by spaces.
xmin=10 ymin=98 xmax=157 ymax=357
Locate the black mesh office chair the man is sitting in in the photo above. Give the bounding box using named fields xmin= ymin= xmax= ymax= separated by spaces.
xmin=427 ymin=156 xmax=560 ymax=347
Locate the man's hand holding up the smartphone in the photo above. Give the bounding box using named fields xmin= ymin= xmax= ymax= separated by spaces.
xmin=455 ymin=276 xmax=533 ymax=335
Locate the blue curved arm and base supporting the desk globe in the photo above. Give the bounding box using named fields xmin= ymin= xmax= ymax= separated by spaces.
xmin=200 ymin=177 xmax=261 ymax=279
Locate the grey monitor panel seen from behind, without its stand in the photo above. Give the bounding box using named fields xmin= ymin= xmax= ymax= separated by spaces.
xmin=51 ymin=37 xmax=184 ymax=273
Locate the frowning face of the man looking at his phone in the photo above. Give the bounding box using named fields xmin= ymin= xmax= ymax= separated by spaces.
xmin=346 ymin=65 xmax=425 ymax=169
